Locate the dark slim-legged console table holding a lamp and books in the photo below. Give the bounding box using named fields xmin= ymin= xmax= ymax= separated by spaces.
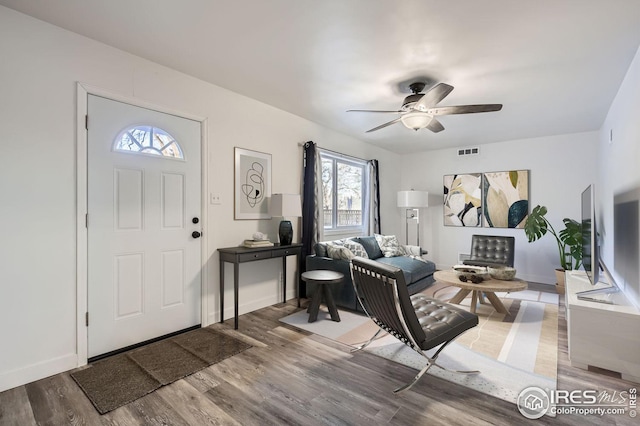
xmin=218 ymin=244 xmax=302 ymax=329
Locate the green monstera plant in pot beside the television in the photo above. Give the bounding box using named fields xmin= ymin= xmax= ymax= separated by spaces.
xmin=524 ymin=205 xmax=582 ymax=293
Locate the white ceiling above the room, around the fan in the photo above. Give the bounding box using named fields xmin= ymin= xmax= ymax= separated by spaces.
xmin=0 ymin=0 xmax=640 ymax=153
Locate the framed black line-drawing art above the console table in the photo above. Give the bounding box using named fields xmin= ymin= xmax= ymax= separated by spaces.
xmin=234 ymin=147 xmax=271 ymax=220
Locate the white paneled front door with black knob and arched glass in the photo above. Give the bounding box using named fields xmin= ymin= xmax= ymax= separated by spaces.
xmin=87 ymin=95 xmax=202 ymax=357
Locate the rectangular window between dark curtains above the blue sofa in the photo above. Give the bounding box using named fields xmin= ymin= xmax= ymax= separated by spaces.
xmin=320 ymin=152 xmax=368 ymax=232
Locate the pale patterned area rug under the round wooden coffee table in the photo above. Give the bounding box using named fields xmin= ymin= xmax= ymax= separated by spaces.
xmin=280 ymin=283 xmax=558 ymax=403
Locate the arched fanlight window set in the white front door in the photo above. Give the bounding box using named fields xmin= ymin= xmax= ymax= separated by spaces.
xmin=114 ymin=126 xmax=184 ymax=159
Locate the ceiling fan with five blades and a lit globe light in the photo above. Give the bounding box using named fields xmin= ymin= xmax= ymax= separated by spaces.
xmin=347 ymin=82 xmax=502 ymax=133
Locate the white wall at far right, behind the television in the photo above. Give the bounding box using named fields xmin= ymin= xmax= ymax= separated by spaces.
xmin=596 ymin=44 xmax=640 ymax=308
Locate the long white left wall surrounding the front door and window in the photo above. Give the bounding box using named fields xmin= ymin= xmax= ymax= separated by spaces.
xmin=0 ymin=7 xmax=399 ymax=391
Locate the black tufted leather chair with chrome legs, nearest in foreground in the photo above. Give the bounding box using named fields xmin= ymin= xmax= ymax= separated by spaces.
xmin=351 ymin=257 xmax=478 ymax=393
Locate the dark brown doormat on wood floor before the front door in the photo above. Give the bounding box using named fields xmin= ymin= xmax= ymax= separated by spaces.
xmin=71 ymin=328 xmax=251 ymax=414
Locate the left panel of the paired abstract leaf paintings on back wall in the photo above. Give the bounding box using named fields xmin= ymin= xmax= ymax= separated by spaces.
xmin=444 ymin=173 xmax=482 ymax=227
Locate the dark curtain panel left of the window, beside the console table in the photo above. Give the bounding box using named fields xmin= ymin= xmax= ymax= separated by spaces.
xmin=298 ymin=141 xmax=318 ymax=295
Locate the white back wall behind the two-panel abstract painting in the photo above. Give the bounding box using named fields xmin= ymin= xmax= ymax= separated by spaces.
xmin=402 ymin=131 xmax=598 ymax=284
